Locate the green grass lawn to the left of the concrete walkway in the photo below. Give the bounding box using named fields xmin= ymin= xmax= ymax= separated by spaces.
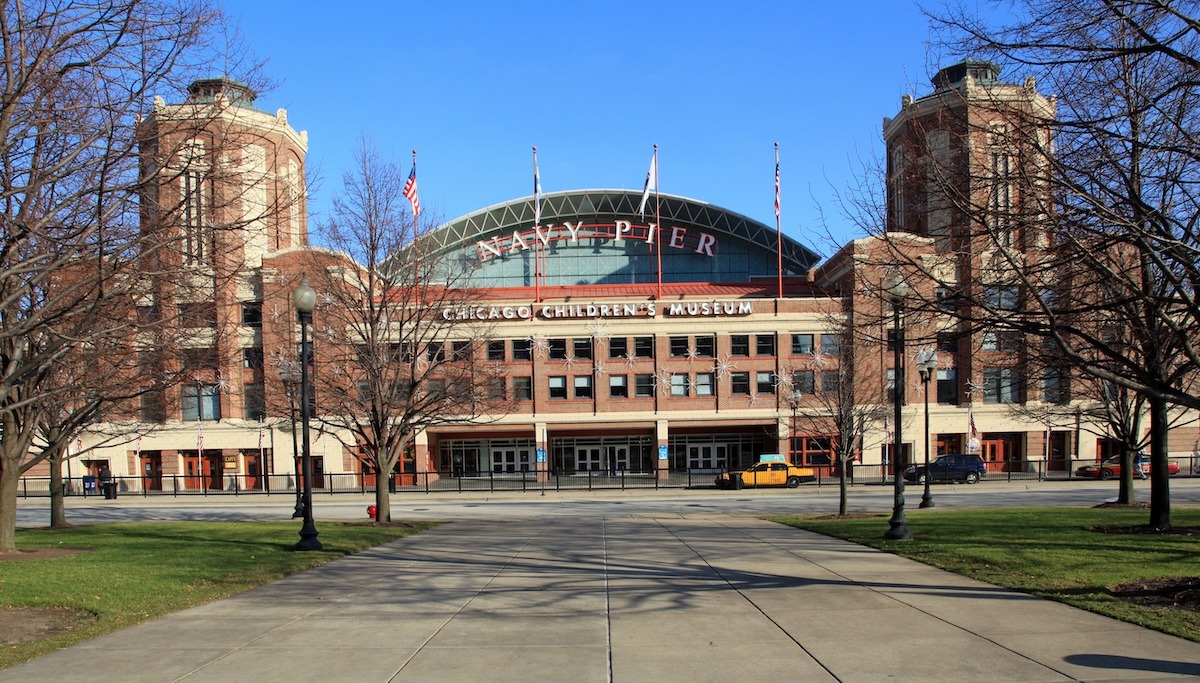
xmin=0 ymin=522 xmax=436 ymax=669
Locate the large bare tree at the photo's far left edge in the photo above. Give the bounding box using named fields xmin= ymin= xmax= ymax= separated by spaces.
xmin=0 ymin=0 xmax=265 ymax=552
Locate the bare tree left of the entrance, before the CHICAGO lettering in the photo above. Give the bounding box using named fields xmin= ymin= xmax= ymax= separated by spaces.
xmin=300 ymin=140 xmax=509 ymax=522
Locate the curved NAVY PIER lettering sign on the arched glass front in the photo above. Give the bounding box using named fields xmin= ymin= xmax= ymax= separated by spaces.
xmin=475 ymin=221 xmax=716 ymax=260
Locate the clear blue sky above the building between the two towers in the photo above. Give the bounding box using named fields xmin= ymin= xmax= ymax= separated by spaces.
xmin=224 ymin=0 xmax=955 ymax=256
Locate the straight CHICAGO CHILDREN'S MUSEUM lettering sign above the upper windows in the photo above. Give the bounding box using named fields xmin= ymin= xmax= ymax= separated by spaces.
xmin=442 ymin=301 xmax=754 ymax=320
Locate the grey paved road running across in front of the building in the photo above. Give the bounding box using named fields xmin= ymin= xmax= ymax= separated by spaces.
xmin=17 ymin=479 xmax=1200 ymax=527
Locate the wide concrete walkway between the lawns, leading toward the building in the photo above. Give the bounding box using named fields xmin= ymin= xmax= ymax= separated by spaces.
xmin=0 ymin=516 xmax=1200 ymax=683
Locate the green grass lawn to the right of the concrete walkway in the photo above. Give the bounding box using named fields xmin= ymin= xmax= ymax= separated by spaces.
xmin=774 ymin=508 xmax=1200 ymax=642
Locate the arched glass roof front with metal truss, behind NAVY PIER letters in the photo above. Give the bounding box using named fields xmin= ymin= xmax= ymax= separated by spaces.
xmin=410 ymin=190 xmax=820 ymax=287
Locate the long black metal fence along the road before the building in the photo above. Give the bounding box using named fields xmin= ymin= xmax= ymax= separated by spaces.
xmin=18 ymin=456 xmax=1200 ymax=498
